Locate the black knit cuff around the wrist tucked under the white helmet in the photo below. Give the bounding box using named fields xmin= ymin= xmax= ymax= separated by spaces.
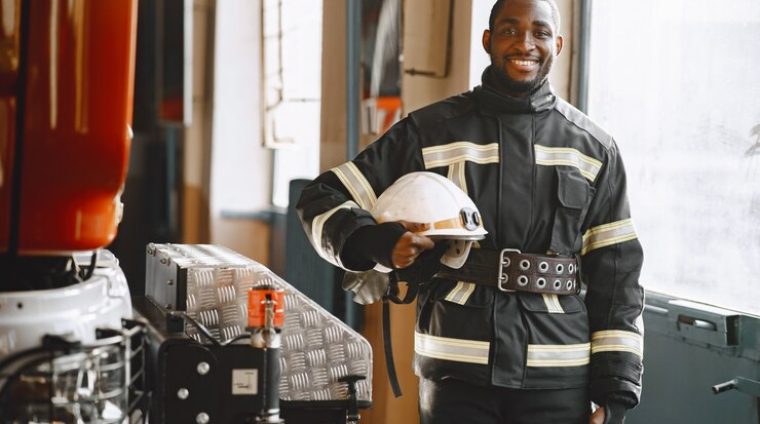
xmin=340 ymin=222 xmax=406 ymax=271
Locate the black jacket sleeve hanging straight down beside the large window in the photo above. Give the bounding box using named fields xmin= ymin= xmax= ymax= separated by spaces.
xmin=581 ymin=141 xmax=644 ymax=408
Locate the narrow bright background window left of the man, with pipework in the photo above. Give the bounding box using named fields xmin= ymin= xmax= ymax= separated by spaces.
xmin=262 ymin=0 xmax=322 ymax=207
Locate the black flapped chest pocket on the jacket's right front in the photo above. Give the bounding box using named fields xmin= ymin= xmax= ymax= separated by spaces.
xmin=550 ymin=167 xmax=596 ymax=255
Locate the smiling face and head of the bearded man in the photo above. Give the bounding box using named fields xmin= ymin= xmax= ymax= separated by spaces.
xmin=483 ymin=0 xmax=563 ymax=96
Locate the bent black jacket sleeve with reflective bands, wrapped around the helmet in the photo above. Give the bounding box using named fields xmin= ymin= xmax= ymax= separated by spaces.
xmin=296 ymin=118 xmax=424 ymax=271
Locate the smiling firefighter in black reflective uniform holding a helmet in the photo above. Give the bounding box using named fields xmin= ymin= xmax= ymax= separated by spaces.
xmin=297 ymin=0 xmax=643 ymax=424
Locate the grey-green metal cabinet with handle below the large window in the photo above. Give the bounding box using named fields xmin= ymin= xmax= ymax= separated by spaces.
xmin=626 ymin=292 xmax=760 ymax=424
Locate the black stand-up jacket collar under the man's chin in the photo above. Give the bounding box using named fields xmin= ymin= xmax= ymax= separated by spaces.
xmin=474 ymin=66 xmax=557 ymax=115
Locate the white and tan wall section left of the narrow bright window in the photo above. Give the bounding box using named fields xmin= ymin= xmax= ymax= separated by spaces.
xmin=182 ymin=0 xmax=272 ymax=265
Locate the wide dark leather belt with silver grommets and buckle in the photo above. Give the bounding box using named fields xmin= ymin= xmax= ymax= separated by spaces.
xmin=435 ymin=249 xmax=581 ymax=295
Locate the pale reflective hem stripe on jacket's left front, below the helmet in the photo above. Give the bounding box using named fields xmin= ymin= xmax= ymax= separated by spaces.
xmin=414 ymin=332 xmax=491 ymax=365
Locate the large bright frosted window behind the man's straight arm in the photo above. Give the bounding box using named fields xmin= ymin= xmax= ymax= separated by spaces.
xmin=588 ymin=0 xmax=760 ymax=315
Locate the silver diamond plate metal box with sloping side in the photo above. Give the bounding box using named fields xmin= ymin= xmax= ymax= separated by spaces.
xmin=145 ymin=243 xmax=372 ymax=401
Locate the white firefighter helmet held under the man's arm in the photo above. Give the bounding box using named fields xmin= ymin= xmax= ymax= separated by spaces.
xmin=371 ymin=172 xmax=488 ymax=268
